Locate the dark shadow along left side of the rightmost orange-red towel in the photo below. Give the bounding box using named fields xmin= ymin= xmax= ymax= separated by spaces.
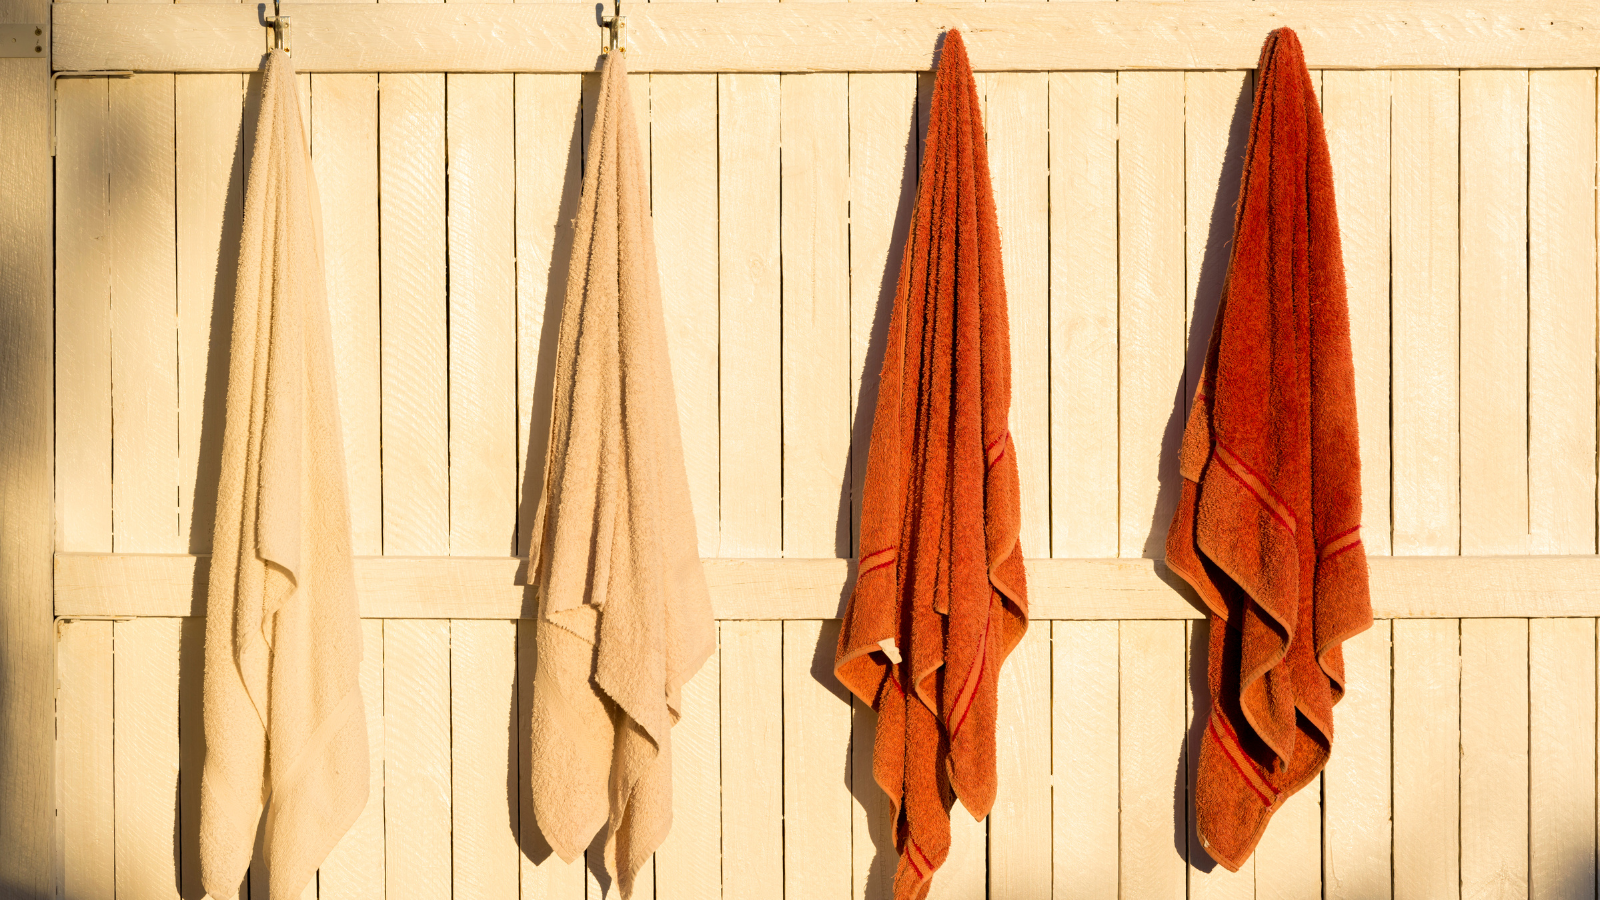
xmin=1171 ymin=74 xmax=1254 ymax=873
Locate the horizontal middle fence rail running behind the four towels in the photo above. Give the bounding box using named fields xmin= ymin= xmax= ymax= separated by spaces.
xmin=56 ymin=552 xmax=1600 ymax=620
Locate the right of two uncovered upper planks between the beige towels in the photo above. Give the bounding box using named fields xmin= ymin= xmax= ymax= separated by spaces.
xmin=445 ymin=74 xmax=517 ymax=556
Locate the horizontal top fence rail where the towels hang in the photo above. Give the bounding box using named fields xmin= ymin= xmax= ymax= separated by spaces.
xmin=53 ymin=0 xmax=1600 ymax=72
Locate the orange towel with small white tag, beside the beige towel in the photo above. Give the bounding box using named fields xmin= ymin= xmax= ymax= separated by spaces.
xmin=834 ymin=30 xmax=1027 ymax=900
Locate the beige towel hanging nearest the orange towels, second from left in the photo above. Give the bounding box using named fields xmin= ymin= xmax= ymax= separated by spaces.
xmin=530 ymin=53 xmax=717 ymax=897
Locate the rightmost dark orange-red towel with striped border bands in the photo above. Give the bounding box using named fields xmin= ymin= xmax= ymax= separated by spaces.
xmin=1166 ymin=29 xmax=1373 ymax=870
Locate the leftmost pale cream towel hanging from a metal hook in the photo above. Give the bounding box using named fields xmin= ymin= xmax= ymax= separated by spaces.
xmin=200 ymin=51 xmax=366 ymax=900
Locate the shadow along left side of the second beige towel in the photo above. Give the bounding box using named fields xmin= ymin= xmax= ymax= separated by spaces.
xmin=506 ymin=80 xmax=588 ymax=871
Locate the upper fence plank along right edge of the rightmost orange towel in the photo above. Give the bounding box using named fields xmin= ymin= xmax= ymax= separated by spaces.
xmin=1322 ymin=72 xmax=1392 ymax=554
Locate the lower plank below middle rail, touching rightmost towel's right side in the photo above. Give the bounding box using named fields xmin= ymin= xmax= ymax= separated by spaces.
xmin=1322 ymin=621 xmax=1392 ymax=900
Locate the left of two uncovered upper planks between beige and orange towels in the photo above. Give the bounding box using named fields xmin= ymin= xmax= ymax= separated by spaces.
xmin=717 ymin=74 xmax=782 ymax=556
